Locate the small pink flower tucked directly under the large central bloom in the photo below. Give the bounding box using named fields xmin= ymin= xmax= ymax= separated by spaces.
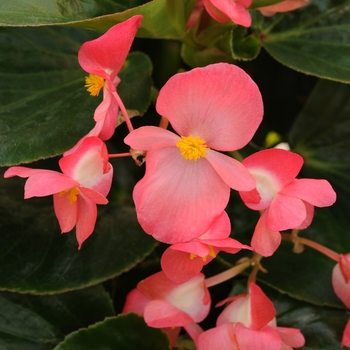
xmin=160 ymin=212 xmax=251 ymax=283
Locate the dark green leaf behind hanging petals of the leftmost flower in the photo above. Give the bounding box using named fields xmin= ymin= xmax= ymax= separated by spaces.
xmin=0 ymin=171 xmax=157 ymax=294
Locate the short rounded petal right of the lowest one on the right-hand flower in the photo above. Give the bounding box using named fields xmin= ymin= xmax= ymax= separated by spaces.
xmin=266 ymin=194 xmax=307 ymax=231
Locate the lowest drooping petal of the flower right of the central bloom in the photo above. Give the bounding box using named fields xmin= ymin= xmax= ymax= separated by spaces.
xmin=250 ymin=212 xmax=282 ymax=257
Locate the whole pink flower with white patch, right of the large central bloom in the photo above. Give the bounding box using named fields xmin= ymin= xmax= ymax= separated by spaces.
xmin=239 ymin=148 xmax=336 ymax=256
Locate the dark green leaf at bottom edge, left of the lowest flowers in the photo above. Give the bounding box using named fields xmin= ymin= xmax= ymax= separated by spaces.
xmin=54 ymin=313 xmax=170 ymax=350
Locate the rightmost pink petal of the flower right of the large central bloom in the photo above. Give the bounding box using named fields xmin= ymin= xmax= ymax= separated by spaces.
xmin=280 ymin=179 xmax=337 ymax=207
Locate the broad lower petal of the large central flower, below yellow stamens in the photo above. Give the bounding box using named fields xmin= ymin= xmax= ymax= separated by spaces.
xmin=133 ymin=147 xmax=230 ymax=244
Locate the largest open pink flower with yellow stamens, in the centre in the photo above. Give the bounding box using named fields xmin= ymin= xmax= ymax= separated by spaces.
xmin=125 ymin=63 xmax=263 ymax=244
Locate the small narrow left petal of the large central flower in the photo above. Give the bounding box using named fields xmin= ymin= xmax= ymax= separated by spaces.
xmin=124 ymin=126 xmax=180 ymax=153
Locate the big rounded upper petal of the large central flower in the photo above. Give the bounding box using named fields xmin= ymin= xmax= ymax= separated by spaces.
xmin=156 ymin=63 xmax=263 ymax=151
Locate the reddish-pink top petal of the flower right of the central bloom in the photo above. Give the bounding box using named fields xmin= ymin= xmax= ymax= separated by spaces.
xmin=242 ymin=148 xmax=304 ymax=190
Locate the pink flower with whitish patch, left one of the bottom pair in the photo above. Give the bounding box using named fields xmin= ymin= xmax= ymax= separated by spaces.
xmin=122 ymin=272 xmax=211 ymax=338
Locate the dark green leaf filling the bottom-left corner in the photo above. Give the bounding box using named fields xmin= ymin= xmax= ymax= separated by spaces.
xmin=0 ymin=286 xmax=114 ymax=350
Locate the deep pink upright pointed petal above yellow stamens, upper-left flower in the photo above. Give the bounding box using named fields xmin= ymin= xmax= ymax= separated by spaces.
xmin=78 ymin=15 xmax=142 ymax=81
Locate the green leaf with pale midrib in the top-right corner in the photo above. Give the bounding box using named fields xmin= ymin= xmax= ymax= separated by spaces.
xmin=259 ymin=0 xmax=350 ymax=83
